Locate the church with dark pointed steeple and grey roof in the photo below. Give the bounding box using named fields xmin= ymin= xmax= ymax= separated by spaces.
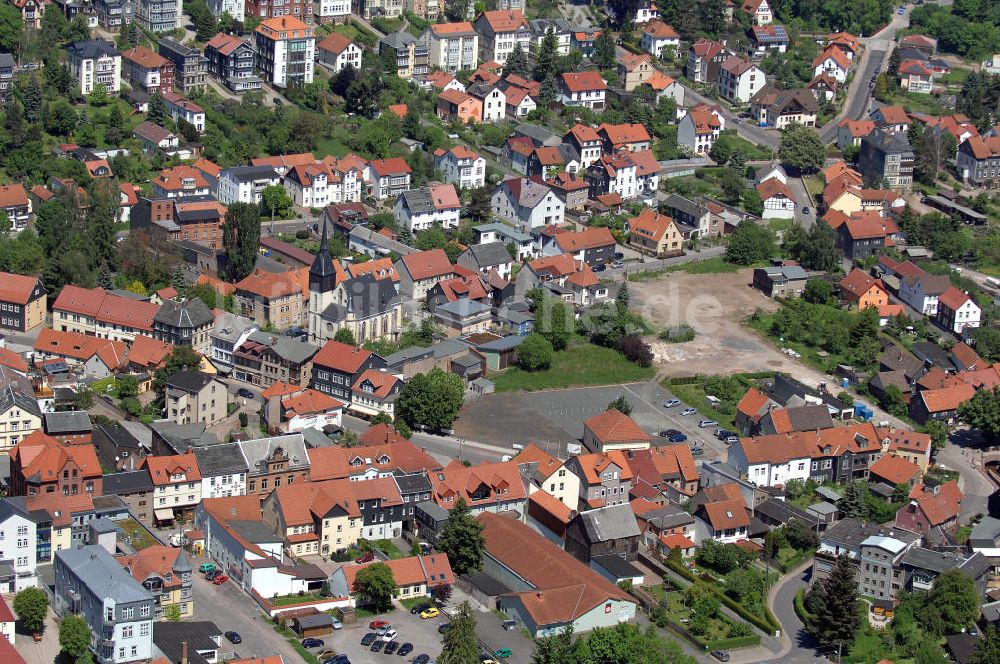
xmin=309 ymin=219 xmax=403 ymax=345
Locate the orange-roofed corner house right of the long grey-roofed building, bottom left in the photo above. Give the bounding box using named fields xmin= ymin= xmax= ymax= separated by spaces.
xmin=115 ymin=544 xmax=194 ymax=620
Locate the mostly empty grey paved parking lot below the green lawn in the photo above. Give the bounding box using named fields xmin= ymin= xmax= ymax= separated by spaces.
xmin=457 ymin=382 xmax=726 ymax=460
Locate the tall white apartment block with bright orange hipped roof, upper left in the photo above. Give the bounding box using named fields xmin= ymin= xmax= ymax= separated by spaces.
xmin=254 ymin=16 xmax=316 ymax=88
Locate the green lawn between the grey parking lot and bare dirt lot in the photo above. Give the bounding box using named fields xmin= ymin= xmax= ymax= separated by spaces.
xmin=490 ymin=343 xmax=653 ymax=392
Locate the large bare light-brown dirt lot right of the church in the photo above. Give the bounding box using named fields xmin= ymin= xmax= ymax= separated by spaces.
xmin=629 ymin=269 xmax=829 ymax=385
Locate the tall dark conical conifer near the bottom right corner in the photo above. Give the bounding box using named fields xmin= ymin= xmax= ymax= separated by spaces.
xmin=806 ymin=555 xmax=861 ymax=648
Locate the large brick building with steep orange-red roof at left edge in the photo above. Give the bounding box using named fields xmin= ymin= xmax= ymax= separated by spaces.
xmin=8 ymin=430 xmax=103 ymax=496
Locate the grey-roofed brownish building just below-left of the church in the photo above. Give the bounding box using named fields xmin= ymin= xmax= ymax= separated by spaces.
xmin=232 ymin=332 xmax=318 ymax=388
